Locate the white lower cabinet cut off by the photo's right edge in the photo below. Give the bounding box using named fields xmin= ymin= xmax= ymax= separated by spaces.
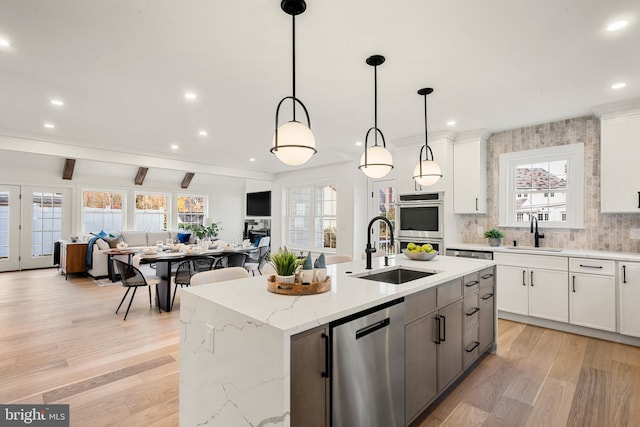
xmin=618 ymin=262 xmax=640 ymax=337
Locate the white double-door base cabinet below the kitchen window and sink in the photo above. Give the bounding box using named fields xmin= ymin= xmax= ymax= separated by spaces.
xmin=494 ymin=252 xmax=569 ymax=322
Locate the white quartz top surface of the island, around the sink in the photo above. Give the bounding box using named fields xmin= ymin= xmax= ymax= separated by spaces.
xmin=181 ymin=255 xmax=495 ymax=335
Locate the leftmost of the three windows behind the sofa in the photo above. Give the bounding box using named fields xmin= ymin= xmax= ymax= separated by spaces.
xmin=82 ymin=191 xmax=126 ymax=233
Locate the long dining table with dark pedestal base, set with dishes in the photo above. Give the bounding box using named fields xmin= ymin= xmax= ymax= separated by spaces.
xmin=140 ymin=246 xmax=258 ymax=311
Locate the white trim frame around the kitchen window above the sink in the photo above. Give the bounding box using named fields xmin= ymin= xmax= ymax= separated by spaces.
xmin=498 ymin=143 xmax=584 ymax=228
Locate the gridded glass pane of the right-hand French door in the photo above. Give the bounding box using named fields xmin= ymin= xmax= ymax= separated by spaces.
xmin=31 ymin=191 xmax=62 ymax=258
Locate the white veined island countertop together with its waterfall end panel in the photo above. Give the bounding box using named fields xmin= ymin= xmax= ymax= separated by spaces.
xmin=180 ymin=255 xmax=495 ymax=426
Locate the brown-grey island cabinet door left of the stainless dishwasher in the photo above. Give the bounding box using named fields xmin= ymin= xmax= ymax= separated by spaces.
xmin=291 ymin=325 xmax=329 ymax=427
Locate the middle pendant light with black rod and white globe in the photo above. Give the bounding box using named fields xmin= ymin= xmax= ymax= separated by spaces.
xmin=358 ymin=55 xmax=393 ymax=178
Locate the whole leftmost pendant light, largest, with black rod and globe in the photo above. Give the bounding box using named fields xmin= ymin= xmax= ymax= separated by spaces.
xmin=270 ymin=0 xmax=318 ymax=166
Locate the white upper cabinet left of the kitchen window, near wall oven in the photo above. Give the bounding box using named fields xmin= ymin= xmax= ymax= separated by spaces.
xmin=453 ymin=132 xmax=487 ymax=214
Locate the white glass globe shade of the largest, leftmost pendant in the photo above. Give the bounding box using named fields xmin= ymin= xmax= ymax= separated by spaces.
xmin=271 ymin=121 xmax=316 ymax=166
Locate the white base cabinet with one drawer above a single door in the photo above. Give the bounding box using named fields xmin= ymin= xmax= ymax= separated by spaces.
xmin=569 ymin=258 xmax=616 ymax=332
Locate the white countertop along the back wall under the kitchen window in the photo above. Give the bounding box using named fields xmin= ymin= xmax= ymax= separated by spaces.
xmin=447 ymin=243 xmax=640 ymax=261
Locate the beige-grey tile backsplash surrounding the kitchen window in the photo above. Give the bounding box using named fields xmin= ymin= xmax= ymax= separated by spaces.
xmin=455 ymin=116 xmax=640 ymax=252
